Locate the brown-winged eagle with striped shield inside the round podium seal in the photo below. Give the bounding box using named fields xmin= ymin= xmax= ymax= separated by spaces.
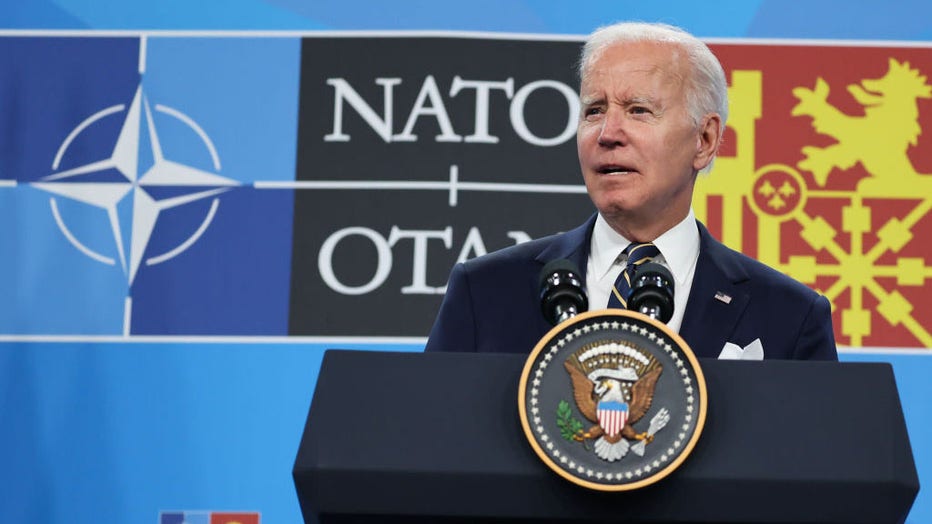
xmin=558 ymin=342 xmax=669 ymax=462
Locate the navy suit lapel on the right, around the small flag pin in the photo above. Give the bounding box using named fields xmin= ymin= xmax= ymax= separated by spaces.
xmin=680 ymin=222 xmax=750 ymax=358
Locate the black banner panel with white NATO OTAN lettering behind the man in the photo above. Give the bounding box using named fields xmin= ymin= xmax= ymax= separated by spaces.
xmin=289 ymin=38 xmax=594 ymax=336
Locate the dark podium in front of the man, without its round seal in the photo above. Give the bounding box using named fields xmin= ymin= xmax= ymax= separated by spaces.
xmin=293 ymin=350 xmax=919 ymax=524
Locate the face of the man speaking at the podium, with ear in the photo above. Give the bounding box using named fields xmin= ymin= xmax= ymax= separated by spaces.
xmin=576 ymin=42 xmax=717 ymax=240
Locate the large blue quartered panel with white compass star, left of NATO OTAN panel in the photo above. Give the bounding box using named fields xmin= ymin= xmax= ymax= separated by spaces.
xmin=0 ymin=34 xmax=300 ymax=336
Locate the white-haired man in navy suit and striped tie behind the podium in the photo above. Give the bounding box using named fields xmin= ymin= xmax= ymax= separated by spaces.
xmin=427 ymin=23 xmax=838 ymax=360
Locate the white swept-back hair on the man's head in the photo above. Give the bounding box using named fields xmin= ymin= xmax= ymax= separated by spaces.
xmin=579 ymin=22 xmax=728 ymax=129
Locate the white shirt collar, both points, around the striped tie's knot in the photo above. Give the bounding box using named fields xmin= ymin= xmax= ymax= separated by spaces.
xmin=589 ymin=208 xmax=699 ymax=284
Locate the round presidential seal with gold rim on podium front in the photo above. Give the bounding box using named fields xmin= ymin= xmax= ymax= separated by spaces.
xmin=518 ymin=309 xmax=707 ymax=491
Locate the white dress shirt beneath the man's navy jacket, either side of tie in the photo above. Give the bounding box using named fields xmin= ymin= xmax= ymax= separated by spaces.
xmin=586 ymin=208 xmax=699 ymax=333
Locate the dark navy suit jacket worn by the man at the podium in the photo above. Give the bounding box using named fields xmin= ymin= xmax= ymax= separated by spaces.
xmin=427 ymin=216 xmax=838 ymax=360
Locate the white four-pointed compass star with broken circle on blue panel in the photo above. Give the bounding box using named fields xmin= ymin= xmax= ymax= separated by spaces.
xmin=31 ymin=85 xmax=240 ymax=286
